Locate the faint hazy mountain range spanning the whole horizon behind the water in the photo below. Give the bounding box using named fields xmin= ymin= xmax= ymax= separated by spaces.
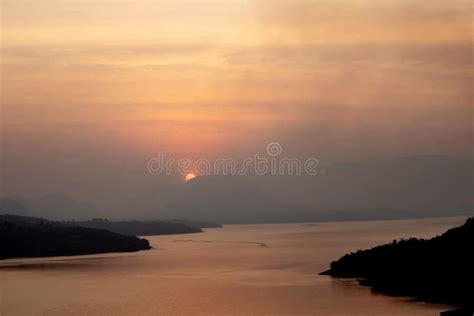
xmin=0 ymin=155 xmax=474 ymax=222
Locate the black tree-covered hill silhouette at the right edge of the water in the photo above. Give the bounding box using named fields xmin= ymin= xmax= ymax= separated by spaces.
xmin=321 ymin=218 xmax=474 ymax=315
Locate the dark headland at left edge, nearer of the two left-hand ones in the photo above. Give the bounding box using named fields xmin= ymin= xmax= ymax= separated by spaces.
xmin=0 ymin=215 xmax=151 ymax=259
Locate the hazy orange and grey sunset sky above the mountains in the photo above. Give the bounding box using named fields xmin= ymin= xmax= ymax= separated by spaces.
xmin=1 ymin=0 xmax=473 ymax=202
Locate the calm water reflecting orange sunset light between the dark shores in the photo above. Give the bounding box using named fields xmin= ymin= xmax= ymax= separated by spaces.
xmin=0 ymin=217 xmax=464 ymax=316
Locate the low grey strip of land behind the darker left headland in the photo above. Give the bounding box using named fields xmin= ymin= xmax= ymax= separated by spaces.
xmin=62 ymin=218 xmax=202 ymax=236
